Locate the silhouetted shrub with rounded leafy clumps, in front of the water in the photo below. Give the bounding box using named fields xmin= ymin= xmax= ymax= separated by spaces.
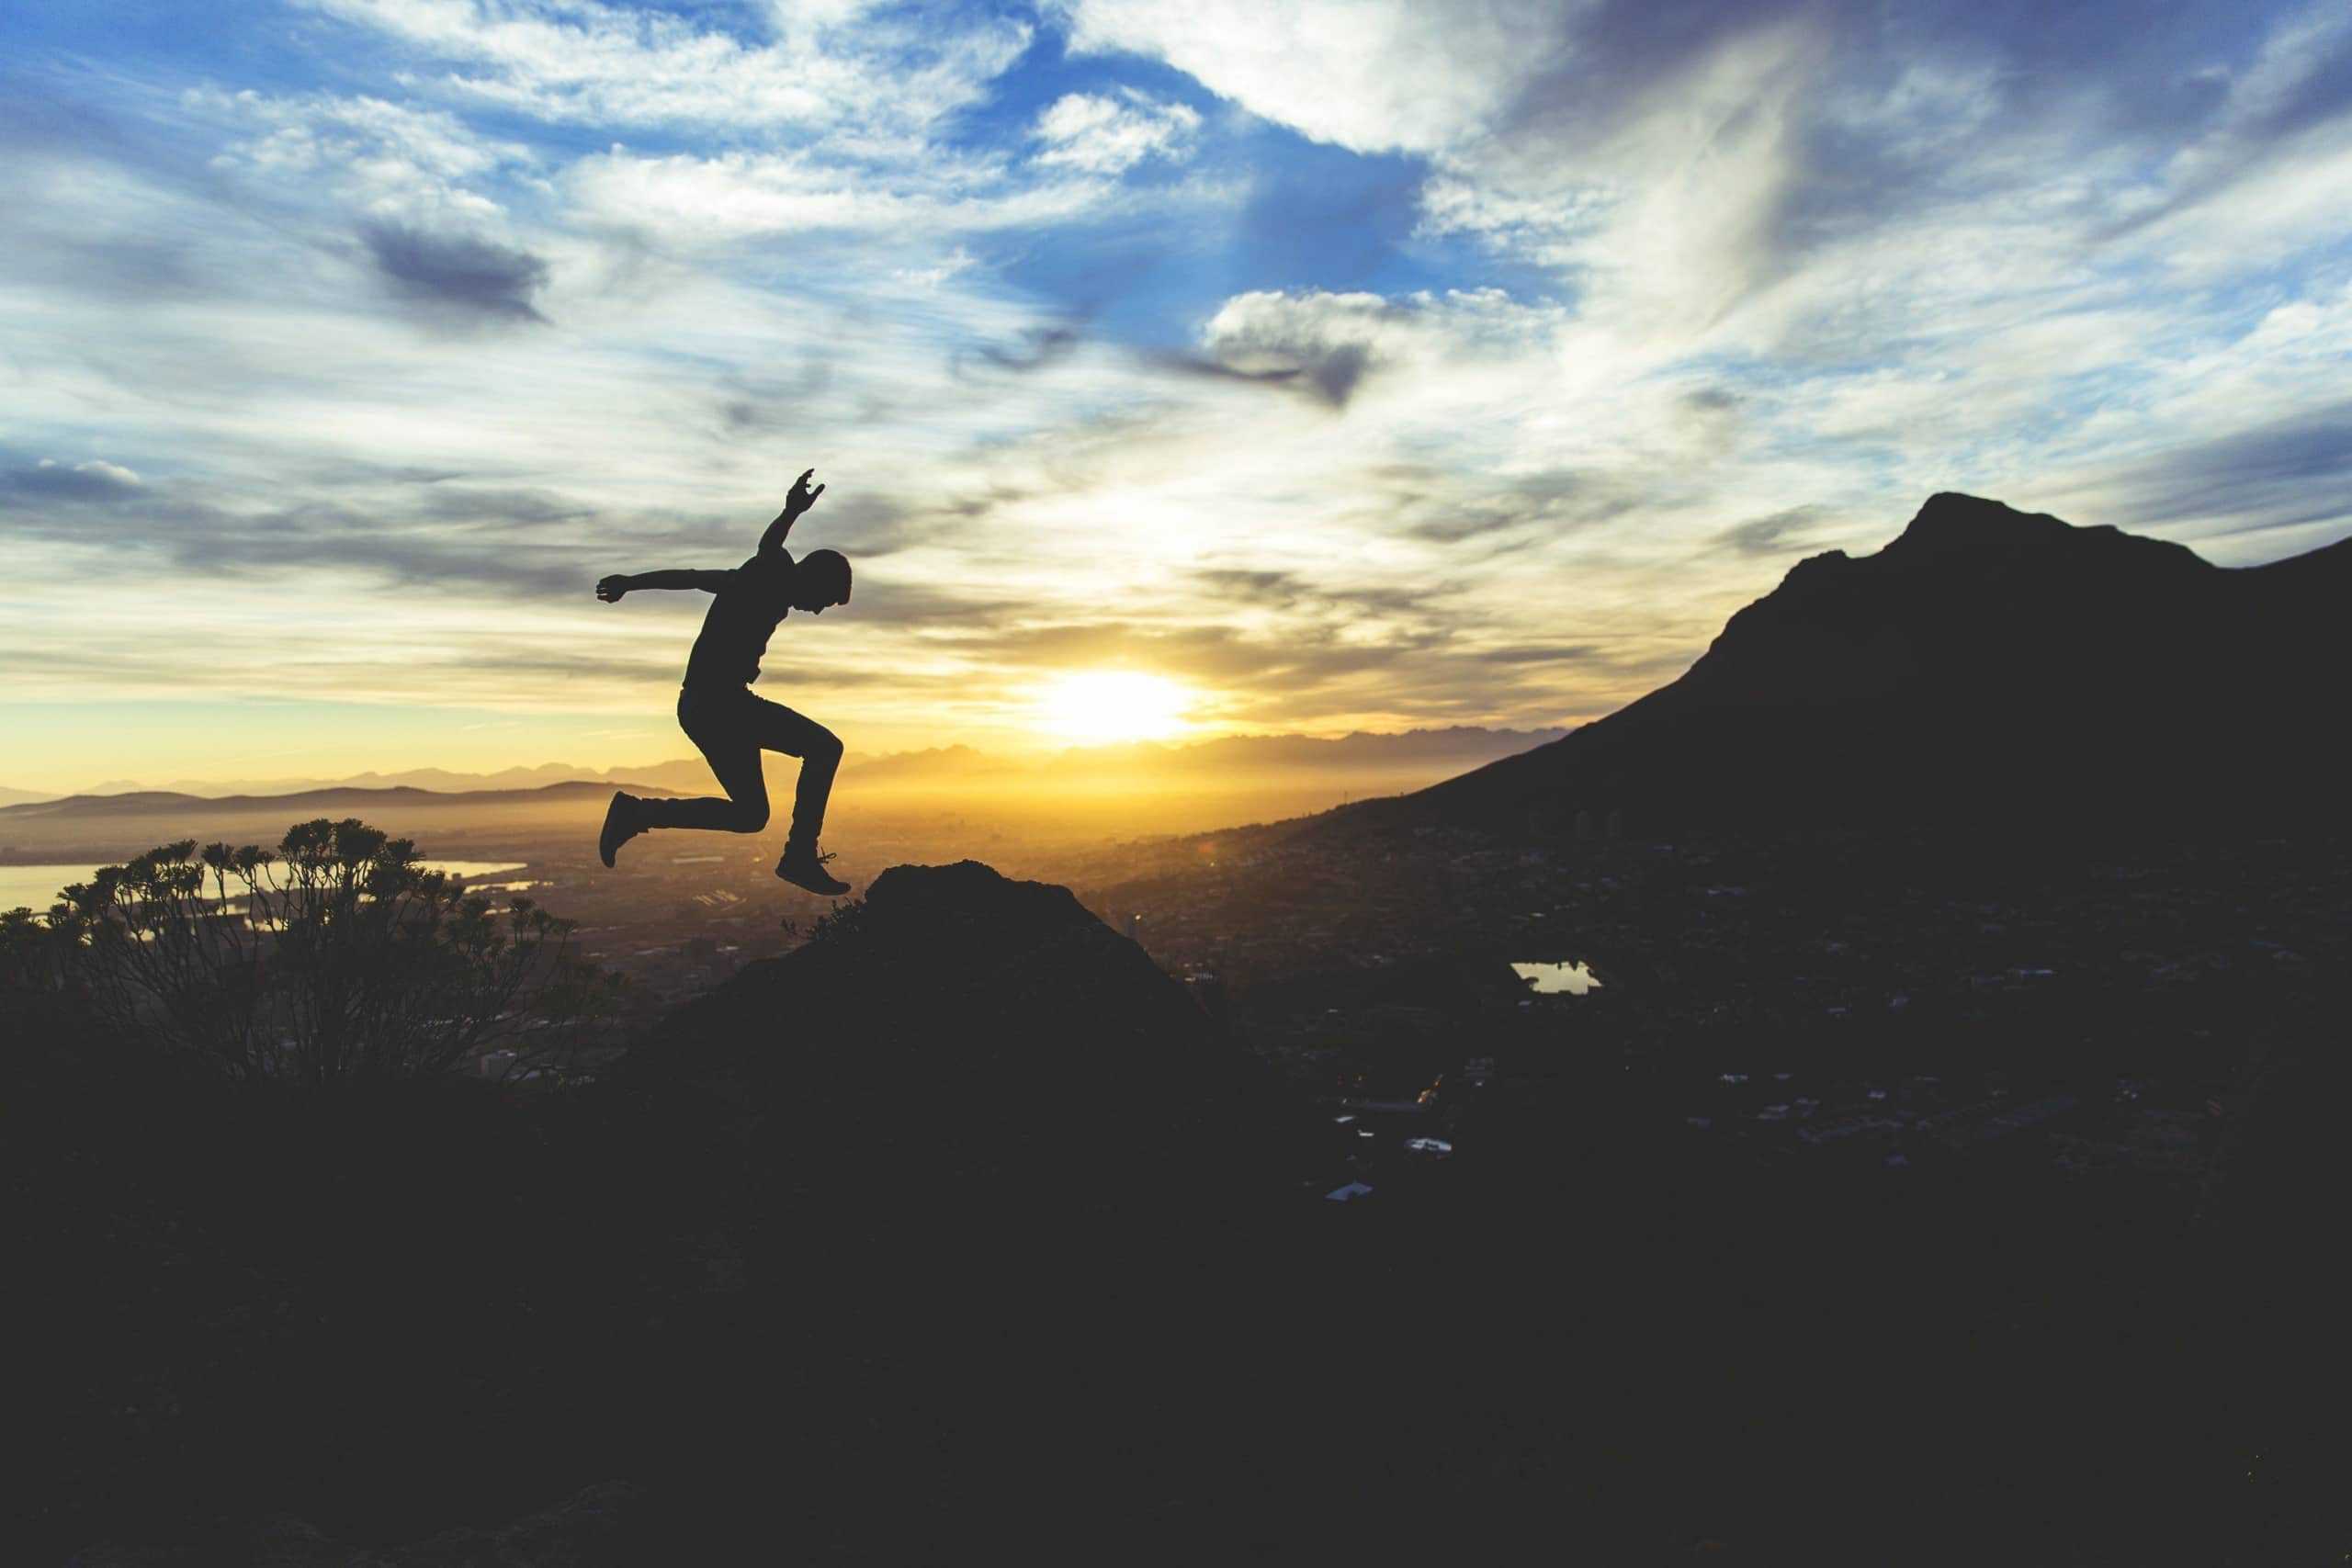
xmin=18 ymin=818 xmax=618 ymax=1084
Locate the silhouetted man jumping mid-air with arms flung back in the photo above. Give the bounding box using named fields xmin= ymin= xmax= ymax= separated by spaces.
xmin=595 ymin=468 xmax=849 ymax=894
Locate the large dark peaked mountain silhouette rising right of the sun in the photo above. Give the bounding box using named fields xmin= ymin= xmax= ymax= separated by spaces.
xmin=1374 ymin=493 xmax=2352 ymax=832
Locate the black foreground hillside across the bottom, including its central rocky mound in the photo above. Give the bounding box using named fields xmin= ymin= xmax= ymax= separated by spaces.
xmin=7 ymin=863 xmax=2345 ymax=1568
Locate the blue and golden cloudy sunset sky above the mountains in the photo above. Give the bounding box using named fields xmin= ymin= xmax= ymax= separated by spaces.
xmin=0 ymin=0 xmax=2352 ymax=790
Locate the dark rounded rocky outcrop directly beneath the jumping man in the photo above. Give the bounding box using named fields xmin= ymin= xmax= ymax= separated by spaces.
xmin=630 ymin=861 xmax=1294 ymax=1239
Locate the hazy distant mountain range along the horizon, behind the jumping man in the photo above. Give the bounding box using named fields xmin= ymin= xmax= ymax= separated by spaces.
xmin=32 ymin=727 xmax=1566 ymax=807
